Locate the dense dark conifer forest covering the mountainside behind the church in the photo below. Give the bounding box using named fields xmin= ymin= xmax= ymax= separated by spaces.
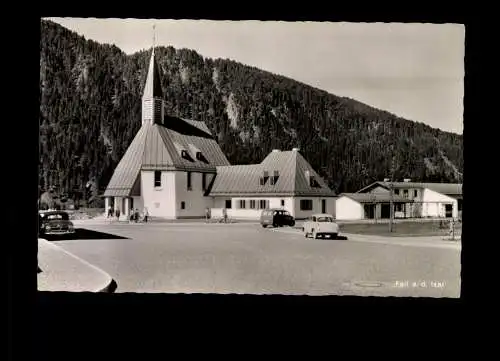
xmin=39 ymin=20 xmax=463 ymax=205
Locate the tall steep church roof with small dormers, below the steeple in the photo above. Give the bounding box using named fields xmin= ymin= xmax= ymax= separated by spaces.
xmin=104 ymin=117 xmax=229 ymax=197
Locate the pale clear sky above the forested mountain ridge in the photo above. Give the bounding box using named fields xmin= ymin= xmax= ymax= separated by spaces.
xmin=47 ymin=18 xmax=465 ymax=134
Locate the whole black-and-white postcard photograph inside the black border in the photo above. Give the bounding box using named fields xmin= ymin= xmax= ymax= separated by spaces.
xmin=36 ymin=18 xmax=465 ymax=298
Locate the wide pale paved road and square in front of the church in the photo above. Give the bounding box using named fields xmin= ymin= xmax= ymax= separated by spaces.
xmin=50 ymin=223 xmax=460 ymax=297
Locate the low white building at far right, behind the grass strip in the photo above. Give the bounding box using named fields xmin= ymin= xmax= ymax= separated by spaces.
xmin=336 ymin=181 xmax=462 ymax=220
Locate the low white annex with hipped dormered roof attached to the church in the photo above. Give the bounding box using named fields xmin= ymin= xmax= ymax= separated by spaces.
xmin=210 ymin=149 xmax=335 ymax=219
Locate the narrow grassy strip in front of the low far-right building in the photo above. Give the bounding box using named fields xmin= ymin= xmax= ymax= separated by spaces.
xmin=340 ymin=221 xmax=462 ymax=237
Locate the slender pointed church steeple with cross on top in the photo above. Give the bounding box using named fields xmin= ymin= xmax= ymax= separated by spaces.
xmin=142 ymin=26 xmax=164 ymax=124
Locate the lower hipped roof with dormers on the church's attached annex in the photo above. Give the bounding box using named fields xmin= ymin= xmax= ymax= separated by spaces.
xmin=209 ymin=150 xmax=335 ymax=197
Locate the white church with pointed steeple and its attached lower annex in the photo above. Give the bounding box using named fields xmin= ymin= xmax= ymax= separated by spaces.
xmin=103 ymin=47 xmax=335 ymax=219
